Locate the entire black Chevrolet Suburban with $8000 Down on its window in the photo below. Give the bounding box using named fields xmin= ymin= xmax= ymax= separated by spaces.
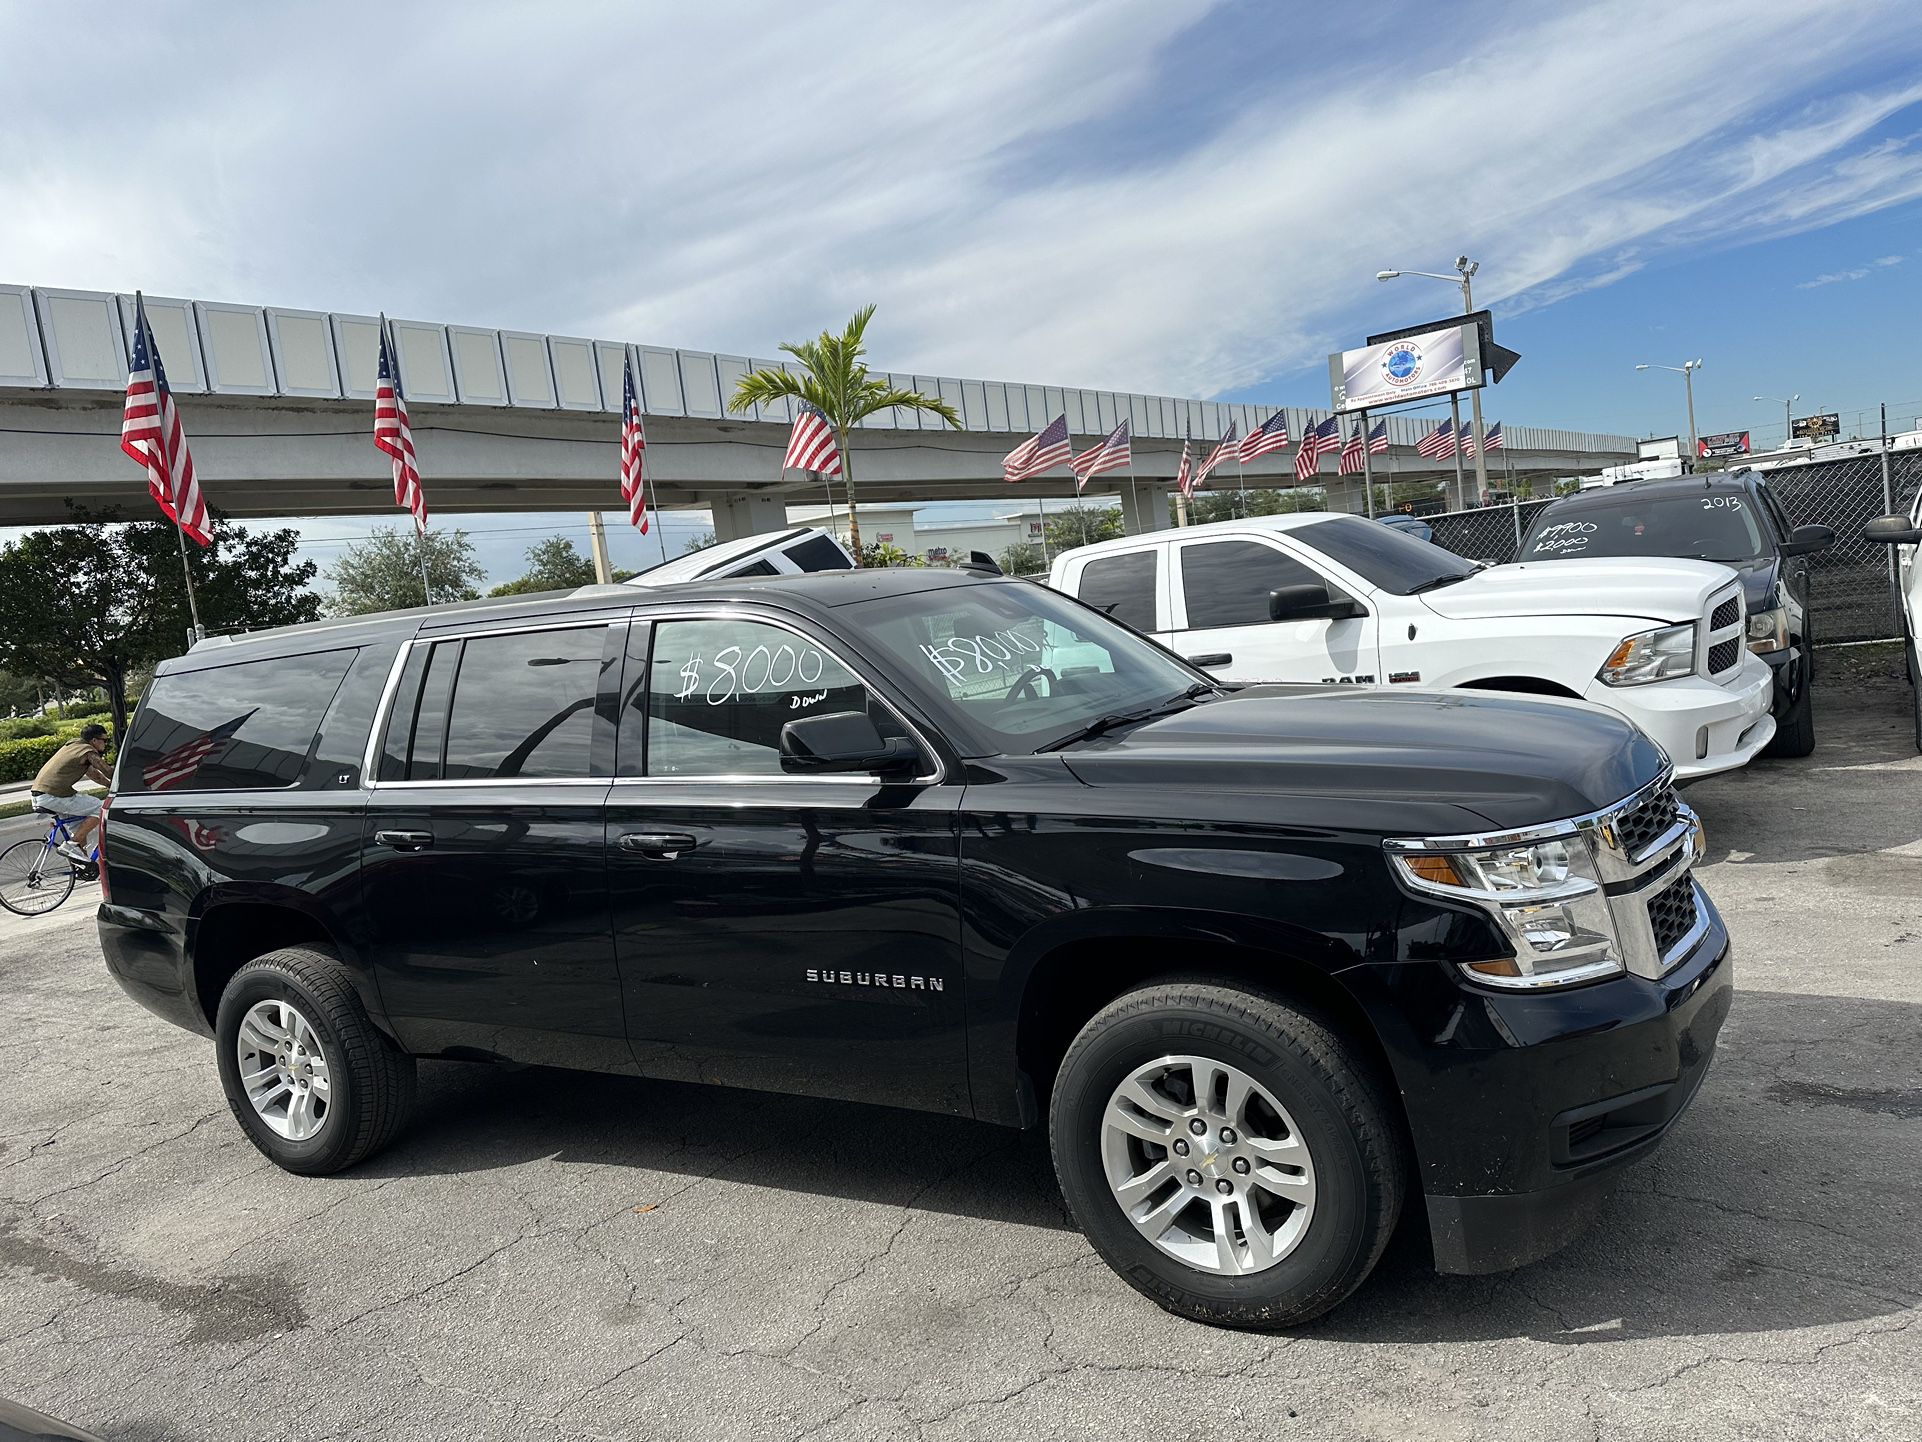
xmin=100 ymin=571 xmax=1734 ymax=1327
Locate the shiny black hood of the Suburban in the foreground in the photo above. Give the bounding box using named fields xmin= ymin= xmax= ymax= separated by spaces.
xmin=1063 ymin=686 xmax=1668 ymax=829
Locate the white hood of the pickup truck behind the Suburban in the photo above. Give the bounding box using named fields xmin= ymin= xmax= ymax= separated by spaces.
xmin=1417 ymin=556 xmax=1752 ymax=621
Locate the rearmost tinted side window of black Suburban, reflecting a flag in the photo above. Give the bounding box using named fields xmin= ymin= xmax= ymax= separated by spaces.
xmin=115 ymin=648 xmax=354 ymax=796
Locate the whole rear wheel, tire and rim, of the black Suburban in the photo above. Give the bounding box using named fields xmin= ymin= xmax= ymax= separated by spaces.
xmin=213 ymin=946 xmax=415 ymax=1175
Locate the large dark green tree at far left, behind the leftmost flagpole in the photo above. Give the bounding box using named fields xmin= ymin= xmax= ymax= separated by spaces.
xmin=0 ymin=510 xmax=321 ymax=738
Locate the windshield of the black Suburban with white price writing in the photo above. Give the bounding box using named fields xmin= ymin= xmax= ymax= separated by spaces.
xmin=846 ymin=583 xmax=1203 ymax=754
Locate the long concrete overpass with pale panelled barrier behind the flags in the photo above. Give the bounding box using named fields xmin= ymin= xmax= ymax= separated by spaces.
xmin=0 ymin=285 xmax=1636 ymax=538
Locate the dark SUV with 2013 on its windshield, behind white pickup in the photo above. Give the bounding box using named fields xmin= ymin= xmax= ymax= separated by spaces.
xmin=1515 ymin=469 xmax=1836 ymax=756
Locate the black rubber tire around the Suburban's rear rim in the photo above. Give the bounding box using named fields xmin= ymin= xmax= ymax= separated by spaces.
xmin=213 ymin=946 xmax=415 ymax=1177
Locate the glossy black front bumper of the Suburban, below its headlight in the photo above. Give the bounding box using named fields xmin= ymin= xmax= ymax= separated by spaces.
xmin=1342 ymin=894 xmax=1736 ymax=1273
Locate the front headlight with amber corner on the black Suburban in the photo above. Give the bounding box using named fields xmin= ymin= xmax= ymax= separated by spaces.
xmin=1390 ymin=833 xmax=1622 ymax=986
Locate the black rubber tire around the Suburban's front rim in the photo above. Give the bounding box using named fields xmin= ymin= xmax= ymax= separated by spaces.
xmin=1049 ymin=981 xmax=1407 ymax=1329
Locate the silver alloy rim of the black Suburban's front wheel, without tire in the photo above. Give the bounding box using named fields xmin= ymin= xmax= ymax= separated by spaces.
xmin=1101 ymin=1056 xmax=1315 ymax=1277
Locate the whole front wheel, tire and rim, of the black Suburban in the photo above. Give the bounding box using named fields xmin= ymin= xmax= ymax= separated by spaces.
xmin=1049 ymin=982 xmax=1405 ymax=1327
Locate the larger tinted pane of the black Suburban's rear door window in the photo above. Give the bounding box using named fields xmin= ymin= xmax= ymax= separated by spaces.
xmin=440 ymin=627 xmax=615 ymax=781
